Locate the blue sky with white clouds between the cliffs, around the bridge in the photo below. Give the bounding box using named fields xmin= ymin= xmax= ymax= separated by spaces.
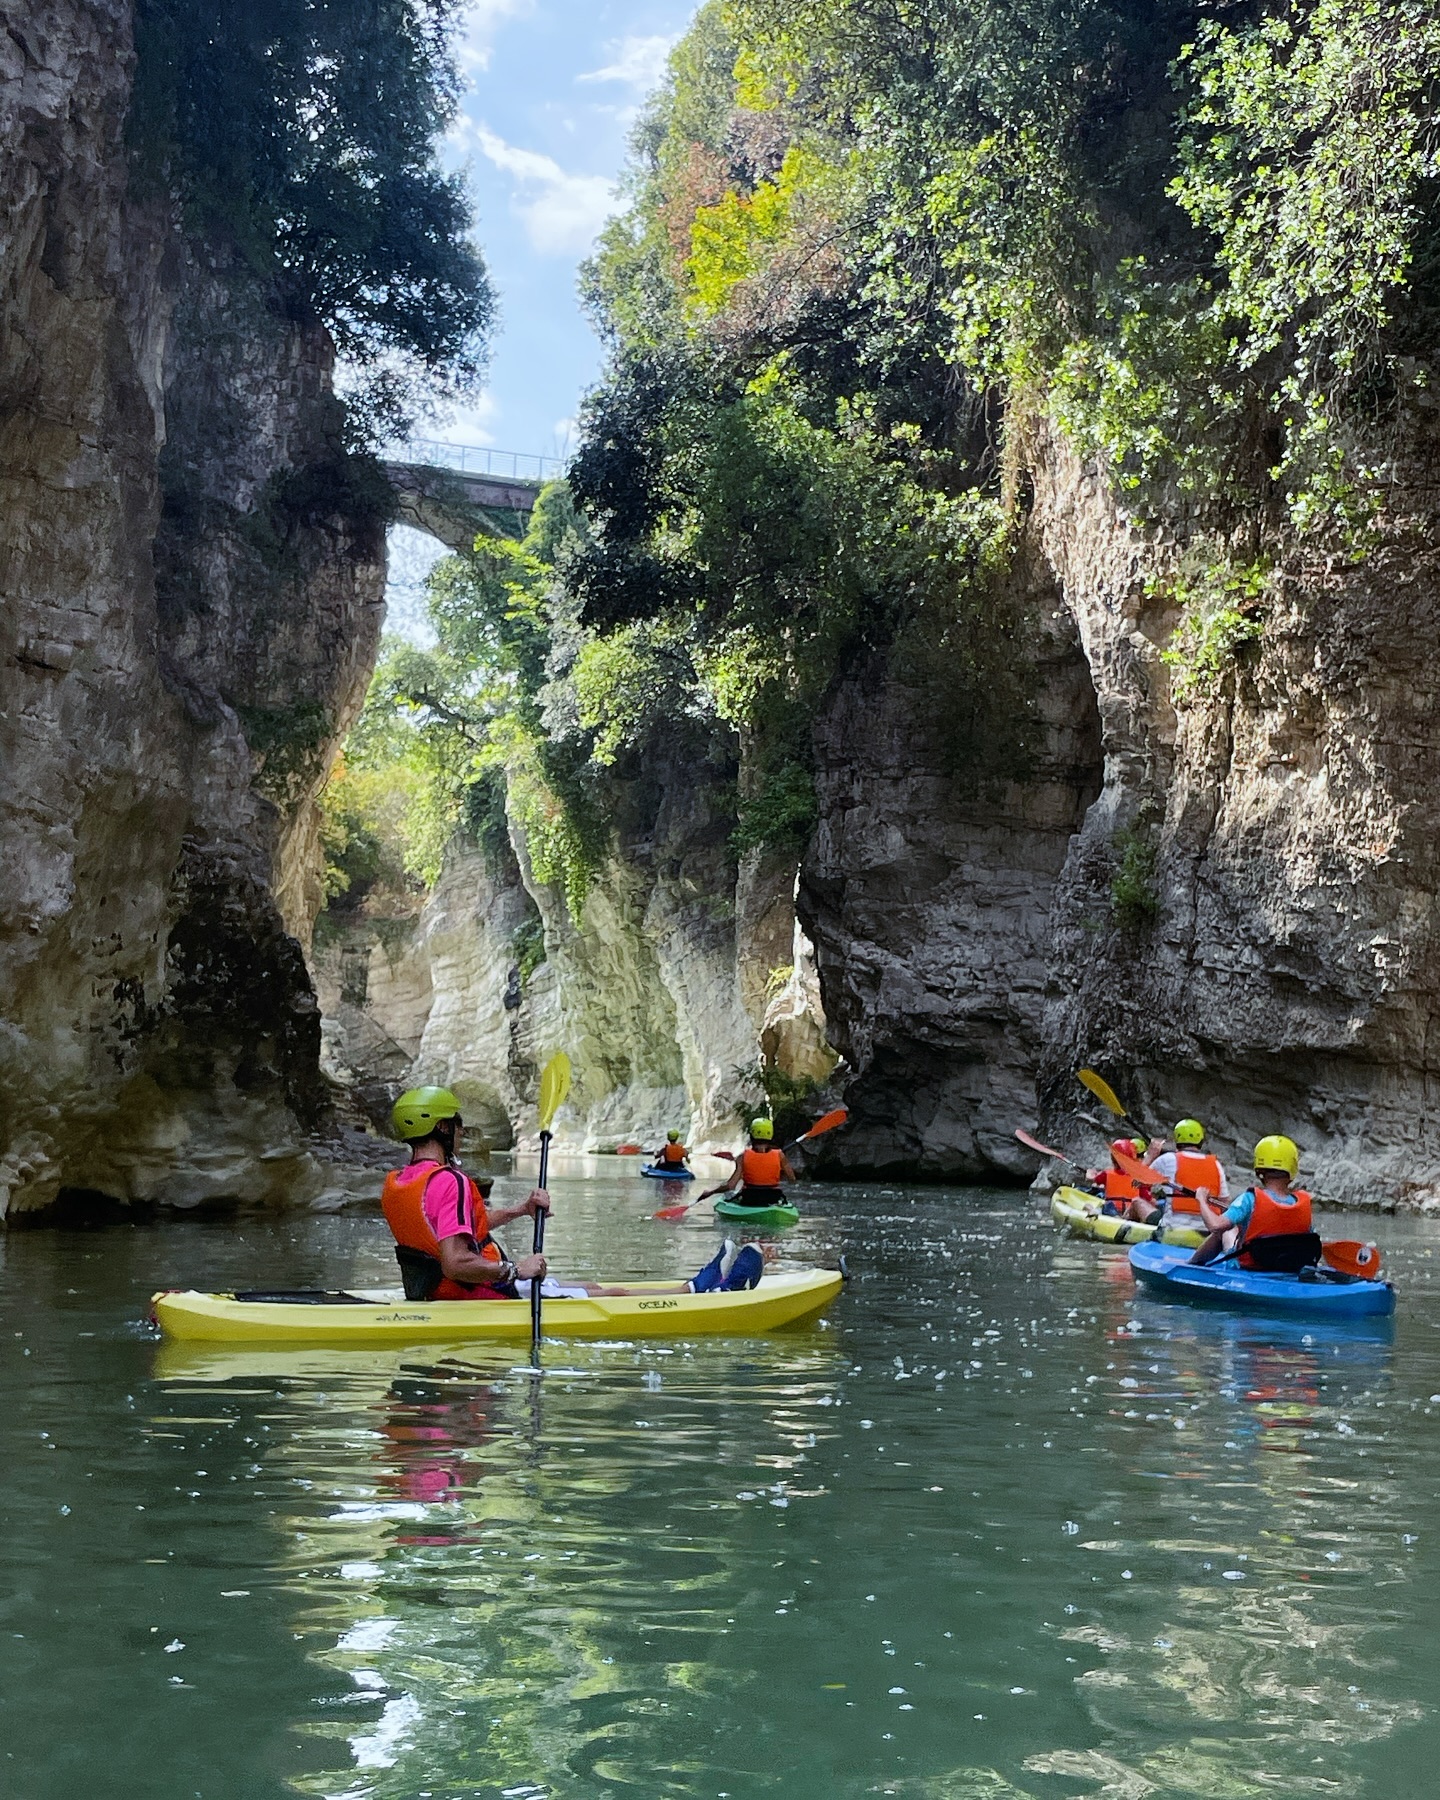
xmin=387 ymin=0 xmax=695 ymax=643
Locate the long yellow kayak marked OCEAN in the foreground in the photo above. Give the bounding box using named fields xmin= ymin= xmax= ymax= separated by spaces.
xmin=153 ymin=1269 xmax=842 ymax=1345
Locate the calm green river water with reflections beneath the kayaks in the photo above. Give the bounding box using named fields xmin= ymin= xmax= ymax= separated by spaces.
xmin=0 ymin=1175 xmax=1440 ymax=1800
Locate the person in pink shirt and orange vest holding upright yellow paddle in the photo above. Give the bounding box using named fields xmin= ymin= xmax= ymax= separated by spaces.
xmin=380 ymin=1087 xmax=763 ymax=1300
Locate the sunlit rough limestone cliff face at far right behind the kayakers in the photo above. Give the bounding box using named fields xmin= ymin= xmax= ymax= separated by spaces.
xmin=1037 ymin=424 xmax=1440 ymax=1204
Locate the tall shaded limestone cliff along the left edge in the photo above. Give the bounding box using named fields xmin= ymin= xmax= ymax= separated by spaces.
xmin=0 ymin=0 xmax=383 ymax=1215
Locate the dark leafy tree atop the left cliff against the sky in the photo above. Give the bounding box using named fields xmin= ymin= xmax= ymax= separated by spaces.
xmin=128 ymin=0 xmax=493 ymax=441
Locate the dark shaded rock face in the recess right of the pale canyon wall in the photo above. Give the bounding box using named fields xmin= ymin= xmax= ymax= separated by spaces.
xmin=799 ymin=587 xmax=1100 ymax=1179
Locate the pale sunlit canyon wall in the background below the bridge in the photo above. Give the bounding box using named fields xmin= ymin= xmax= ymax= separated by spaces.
xmin=319 ymin=733 xmax=833 ymax=1150
